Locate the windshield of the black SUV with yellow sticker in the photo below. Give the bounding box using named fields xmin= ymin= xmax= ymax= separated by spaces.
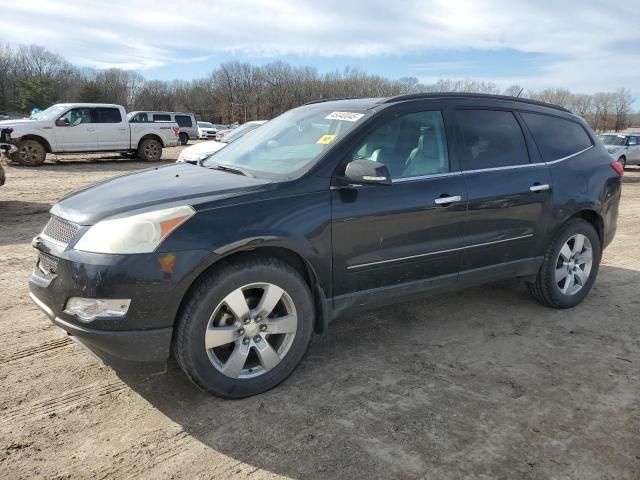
xmin=203 ymin=105 xmax=365 ymax=180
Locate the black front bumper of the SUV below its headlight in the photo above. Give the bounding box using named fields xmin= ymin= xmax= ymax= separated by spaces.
xmin=29 ymin=241 xmax=207 ymax=374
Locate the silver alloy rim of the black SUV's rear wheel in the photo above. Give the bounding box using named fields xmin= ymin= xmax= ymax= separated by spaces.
xmin=556 ymin=233 xmax=593 ymax=295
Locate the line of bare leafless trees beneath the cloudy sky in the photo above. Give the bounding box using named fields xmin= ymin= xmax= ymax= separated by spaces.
xmin=0 ymin=45 xmax=640 ymax=131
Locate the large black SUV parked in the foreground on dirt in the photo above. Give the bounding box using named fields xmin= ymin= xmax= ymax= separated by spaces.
xmin=30 ymin=94 xmax=622 ymax=398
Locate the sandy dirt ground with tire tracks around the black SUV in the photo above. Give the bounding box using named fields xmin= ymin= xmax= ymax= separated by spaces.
xmin=0 ymin=147 xmax=640 ymax=479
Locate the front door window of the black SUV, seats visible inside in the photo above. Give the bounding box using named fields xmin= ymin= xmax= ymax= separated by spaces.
xmin=352 ymin=111 xmax=449 ymax=179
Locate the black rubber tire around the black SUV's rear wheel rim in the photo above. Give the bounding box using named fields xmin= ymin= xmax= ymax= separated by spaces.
xmin=527 ymin=219 xmax=602 ymax=308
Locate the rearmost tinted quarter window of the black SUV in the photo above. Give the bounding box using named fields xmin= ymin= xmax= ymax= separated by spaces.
xmin=520 ymin=112 xmax=592 ymax=162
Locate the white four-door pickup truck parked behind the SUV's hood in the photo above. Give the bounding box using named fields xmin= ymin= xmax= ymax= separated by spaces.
xmin=0 ymin=103 xmax=180 ymax=166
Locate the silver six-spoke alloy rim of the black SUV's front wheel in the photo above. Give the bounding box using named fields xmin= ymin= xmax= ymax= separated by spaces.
xmin=204 ymin=283 xmax=298 ymax=379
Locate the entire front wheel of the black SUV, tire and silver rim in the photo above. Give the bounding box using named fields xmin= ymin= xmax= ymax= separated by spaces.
xmin=173 ymin=258 xmax=314 ymax=398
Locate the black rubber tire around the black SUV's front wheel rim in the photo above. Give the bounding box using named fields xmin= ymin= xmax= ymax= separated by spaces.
xmin=173 ymin=258 xmax=315 ymax=398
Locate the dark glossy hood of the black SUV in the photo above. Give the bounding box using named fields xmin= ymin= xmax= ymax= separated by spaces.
xmin=51 ymin=163 xmax=270 ymax=225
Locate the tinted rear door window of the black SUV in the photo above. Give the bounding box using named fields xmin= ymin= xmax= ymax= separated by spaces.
xmin=455 ymin=110 xmax=529 ymax=170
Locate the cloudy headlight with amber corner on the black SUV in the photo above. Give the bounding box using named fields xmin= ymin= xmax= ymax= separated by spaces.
xmin=73 ymin=206 xmax=196 ymax=254
